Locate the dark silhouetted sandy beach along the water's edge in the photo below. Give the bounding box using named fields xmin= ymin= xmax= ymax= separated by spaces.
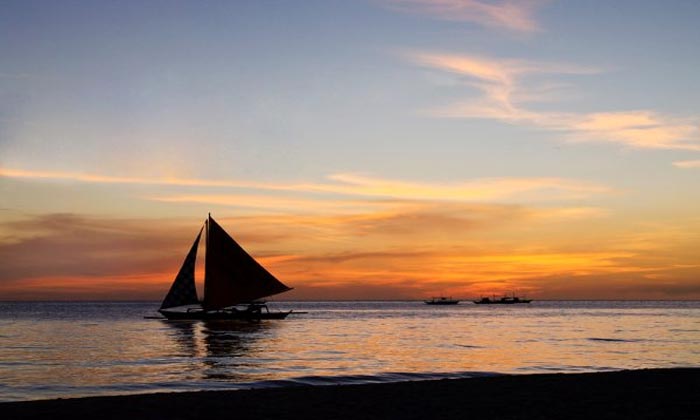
xmin=0 ymin=368 xmax=700 ymax=420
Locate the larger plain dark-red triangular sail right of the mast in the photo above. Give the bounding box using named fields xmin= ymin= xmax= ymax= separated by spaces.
xmin=203 ymin=217 xmax=291 ymax=310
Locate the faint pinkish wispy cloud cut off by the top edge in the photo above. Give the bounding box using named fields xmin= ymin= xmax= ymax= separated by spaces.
xmin=385 ymin=0 xmax=543 ymax=33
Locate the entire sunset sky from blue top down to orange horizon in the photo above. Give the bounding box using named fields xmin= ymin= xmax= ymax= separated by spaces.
xmin=0 ymin=0 xmax=700 ymax=300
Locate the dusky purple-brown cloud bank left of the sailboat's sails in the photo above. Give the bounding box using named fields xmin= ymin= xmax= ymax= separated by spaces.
xmin=0 ymin=214 xmax=197 ymax=283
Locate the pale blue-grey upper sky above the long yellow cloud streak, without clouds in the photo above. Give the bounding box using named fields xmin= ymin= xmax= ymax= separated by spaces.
xmin=2 ymin=1 xmax=700 ymax=180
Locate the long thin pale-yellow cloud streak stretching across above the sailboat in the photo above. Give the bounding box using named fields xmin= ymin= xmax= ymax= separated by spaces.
xmin=0 ymin=168 xmax=611 ymax=203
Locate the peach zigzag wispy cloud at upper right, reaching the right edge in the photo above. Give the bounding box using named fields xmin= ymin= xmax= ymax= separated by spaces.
xmin=409 ymin=53 xmax=700 ymax=151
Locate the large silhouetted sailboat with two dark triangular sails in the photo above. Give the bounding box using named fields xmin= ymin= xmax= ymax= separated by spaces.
xmin=158 ymin=214 xmax=292 ymax=320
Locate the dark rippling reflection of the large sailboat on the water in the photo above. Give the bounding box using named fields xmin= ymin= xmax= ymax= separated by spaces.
xmin=162 ymin=320 xmax=277 ymax=381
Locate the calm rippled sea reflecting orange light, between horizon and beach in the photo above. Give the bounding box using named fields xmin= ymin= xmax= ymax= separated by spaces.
xmin=0 ymin=302 xmax=700 ymax=401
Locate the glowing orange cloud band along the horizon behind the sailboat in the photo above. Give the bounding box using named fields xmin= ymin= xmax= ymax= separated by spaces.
xmin=0 ymin=204 xmax=700 ymax=299
